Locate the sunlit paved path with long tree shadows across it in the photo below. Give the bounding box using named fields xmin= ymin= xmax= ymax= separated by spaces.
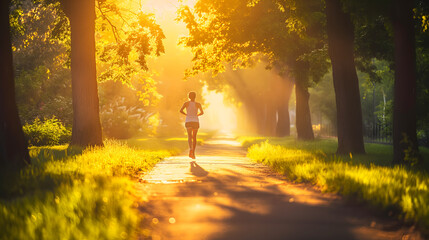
xmin=138 ymin=138 xmax=414 ymax=240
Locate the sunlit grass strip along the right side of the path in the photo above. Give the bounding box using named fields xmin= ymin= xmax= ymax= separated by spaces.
xmin=239 ymin=138 xmax=429 ymax=228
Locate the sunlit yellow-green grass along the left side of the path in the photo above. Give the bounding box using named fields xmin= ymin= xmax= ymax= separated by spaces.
xmin=0 ymin=141 xmax=181 ymax=239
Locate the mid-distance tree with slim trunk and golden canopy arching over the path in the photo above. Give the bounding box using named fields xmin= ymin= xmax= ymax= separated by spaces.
xmin=180 ymin=0 xmax=323 ymax=139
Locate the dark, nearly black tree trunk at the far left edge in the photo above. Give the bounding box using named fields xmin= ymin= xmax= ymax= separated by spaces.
xmin=0 ymin=1 xmax=30 ymax=168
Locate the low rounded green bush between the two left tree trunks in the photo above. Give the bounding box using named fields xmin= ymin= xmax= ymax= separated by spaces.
xmin=23 ymin=116 xmax=71 ymax=146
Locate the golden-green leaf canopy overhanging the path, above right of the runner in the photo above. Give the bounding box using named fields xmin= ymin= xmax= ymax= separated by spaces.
xmin=178 ymin=0 xmax=329 ymax=82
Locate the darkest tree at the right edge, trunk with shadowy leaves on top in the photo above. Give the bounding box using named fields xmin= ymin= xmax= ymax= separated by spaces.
xmin=345 ymin=0 xmax=422 ymax=161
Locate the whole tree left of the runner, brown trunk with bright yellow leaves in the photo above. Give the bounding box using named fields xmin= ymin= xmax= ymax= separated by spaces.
xmin=14 ymin=0 xmax=165 ymax=142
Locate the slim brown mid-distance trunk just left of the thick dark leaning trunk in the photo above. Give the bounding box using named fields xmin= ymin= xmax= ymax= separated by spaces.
xmin=295 ymin=81 xmax=314 ymax=140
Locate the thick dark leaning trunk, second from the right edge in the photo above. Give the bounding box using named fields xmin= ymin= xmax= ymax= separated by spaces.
xmin=326 ymin=0 xmax=365 ymax=154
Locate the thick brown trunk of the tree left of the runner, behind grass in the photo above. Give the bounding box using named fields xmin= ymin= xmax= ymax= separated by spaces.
xmin=62 ymin=0 xmax=103 ymax=146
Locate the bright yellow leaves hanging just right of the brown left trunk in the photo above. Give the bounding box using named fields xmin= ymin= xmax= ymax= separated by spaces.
xmin=96 ymin=0 xmax=165 ymax=88
